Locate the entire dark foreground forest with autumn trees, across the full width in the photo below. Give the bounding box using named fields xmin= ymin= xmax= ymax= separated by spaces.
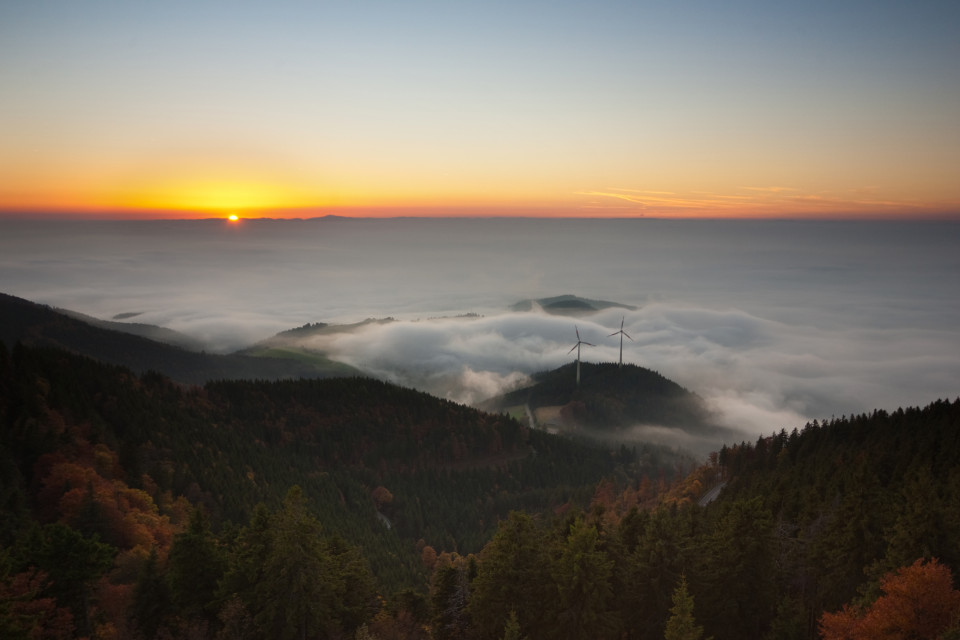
xmin=0 ymin=344 xmax=960 ymax=640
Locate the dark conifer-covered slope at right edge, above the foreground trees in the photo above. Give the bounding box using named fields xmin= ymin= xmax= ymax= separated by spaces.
xmin=718 ymin=400 xmax=960 ymax=596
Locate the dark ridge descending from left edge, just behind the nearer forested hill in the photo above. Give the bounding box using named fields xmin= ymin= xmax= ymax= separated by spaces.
xmin=0 ymin=293 xmax=357 ymax=384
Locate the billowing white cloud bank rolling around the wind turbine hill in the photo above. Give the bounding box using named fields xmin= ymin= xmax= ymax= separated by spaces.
xmin=292 ymin=303 xmax=960 ymax=435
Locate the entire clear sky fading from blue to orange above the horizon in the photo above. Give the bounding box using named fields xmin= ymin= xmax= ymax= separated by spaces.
xmin=0 ymin=0 xmax=960 ymax=219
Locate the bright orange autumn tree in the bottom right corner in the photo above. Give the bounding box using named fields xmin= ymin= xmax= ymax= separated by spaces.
xmin=820 ymin=558 xmax=960 ymax=640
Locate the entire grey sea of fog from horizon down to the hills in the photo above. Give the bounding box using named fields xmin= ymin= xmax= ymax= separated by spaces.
xmin=0 ymin=218 xmax=960 ymax=436
